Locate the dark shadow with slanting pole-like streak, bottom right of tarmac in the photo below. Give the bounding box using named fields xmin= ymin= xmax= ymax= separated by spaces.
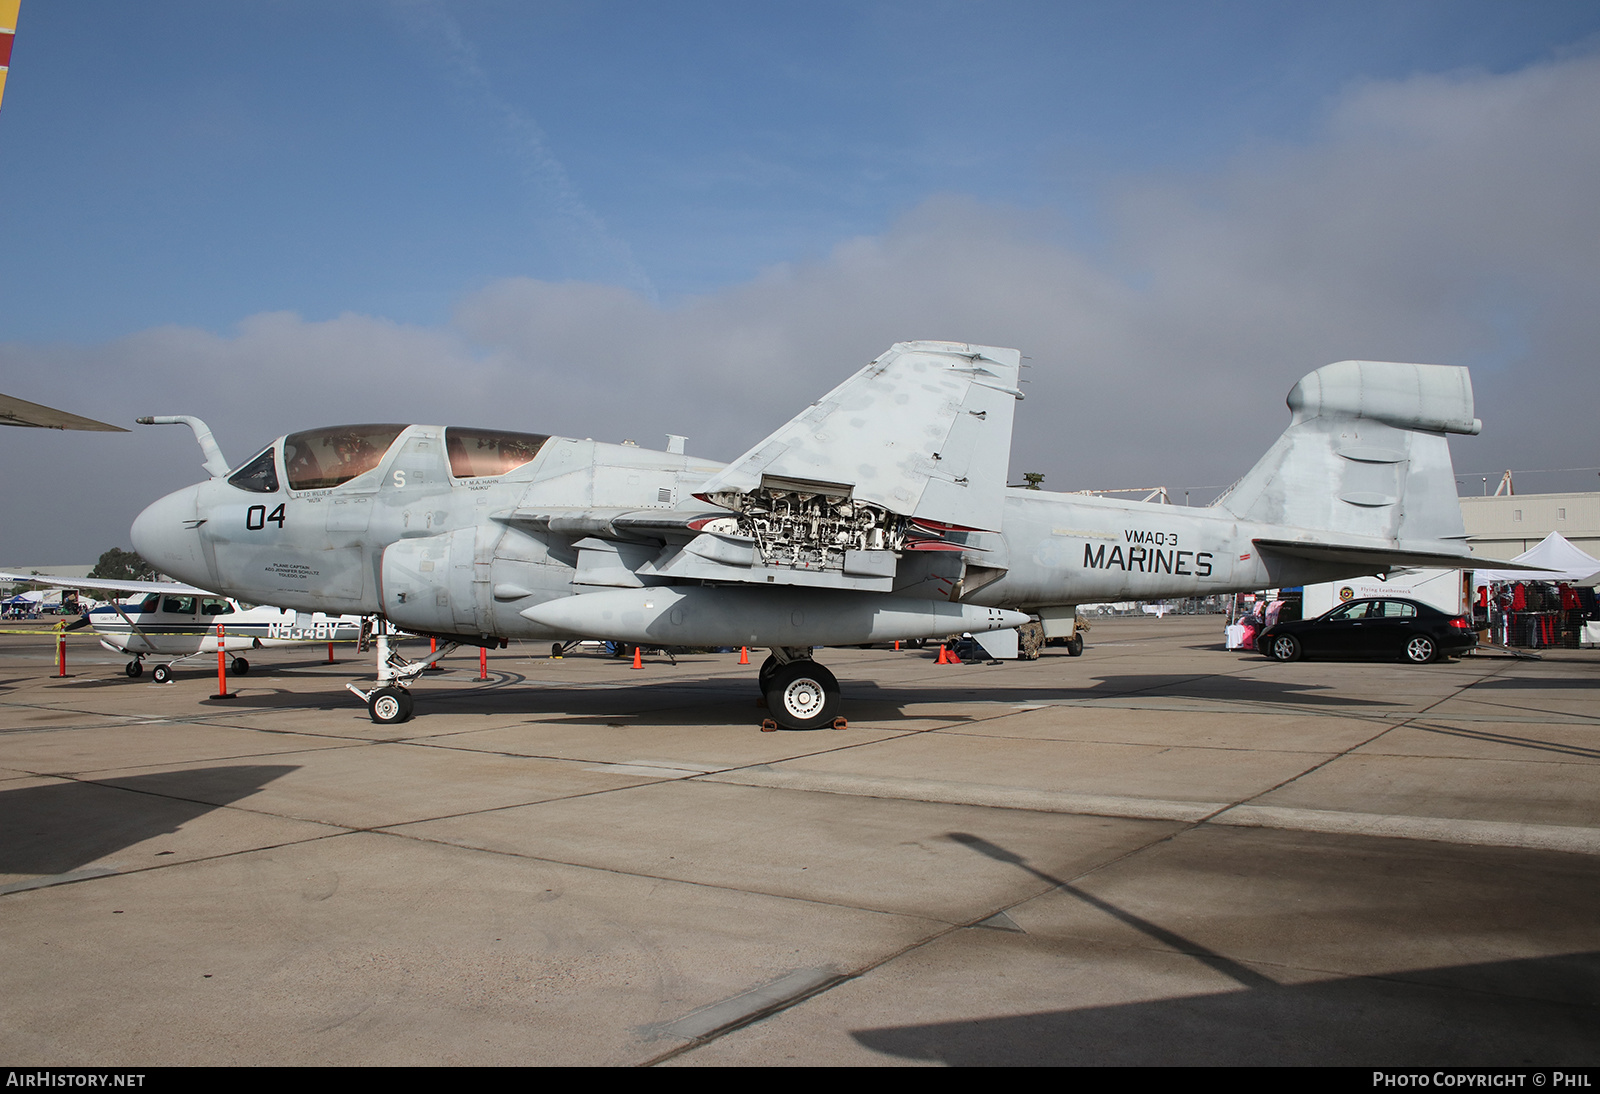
xmin=851 ymin=832 xmax=1600 ymax=1067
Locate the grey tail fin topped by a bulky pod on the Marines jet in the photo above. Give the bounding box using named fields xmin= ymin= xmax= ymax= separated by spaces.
xmin=1218 ymin=361 xmax=1482 ymax=553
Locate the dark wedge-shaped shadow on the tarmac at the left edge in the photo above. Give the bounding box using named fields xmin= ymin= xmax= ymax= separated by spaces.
xmin=0 ymin=765 xmax=298 ymax=876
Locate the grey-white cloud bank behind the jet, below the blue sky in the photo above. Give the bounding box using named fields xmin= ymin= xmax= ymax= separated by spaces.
xmin=0 ymin=44 xmax=1600 ymax=561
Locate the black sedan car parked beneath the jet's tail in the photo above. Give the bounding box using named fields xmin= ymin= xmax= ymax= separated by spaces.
xmin=1256 ymin=597 xmax=1478 ymax=665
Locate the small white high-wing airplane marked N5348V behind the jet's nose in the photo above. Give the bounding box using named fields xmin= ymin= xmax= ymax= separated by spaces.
xmin=0 ymin=573 xmax=362 ymax=683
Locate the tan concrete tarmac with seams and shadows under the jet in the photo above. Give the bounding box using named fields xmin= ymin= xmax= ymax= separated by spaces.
xmin=0 ymin=617 xmax=1600 ymax=1067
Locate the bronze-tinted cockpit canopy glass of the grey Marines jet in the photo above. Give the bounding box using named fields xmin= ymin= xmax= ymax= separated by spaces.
xmin=227 ymin=424 xmax=550 ymax=494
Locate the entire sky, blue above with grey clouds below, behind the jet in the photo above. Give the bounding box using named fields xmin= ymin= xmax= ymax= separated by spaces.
xmin=0 ymin=0 xmax=1600 ymax=561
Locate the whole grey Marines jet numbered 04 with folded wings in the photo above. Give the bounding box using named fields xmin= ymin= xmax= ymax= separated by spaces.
xmin=133 ymin=342 xmax=1480 ymax=729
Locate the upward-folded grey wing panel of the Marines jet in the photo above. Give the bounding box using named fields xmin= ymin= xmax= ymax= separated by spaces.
xmin=699 ymin=342 xmax=1022 ymax=531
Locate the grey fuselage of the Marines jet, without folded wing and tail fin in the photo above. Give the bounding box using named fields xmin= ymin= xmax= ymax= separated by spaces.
xmin=134 ymin=425 xmax=1376 ymax=645
